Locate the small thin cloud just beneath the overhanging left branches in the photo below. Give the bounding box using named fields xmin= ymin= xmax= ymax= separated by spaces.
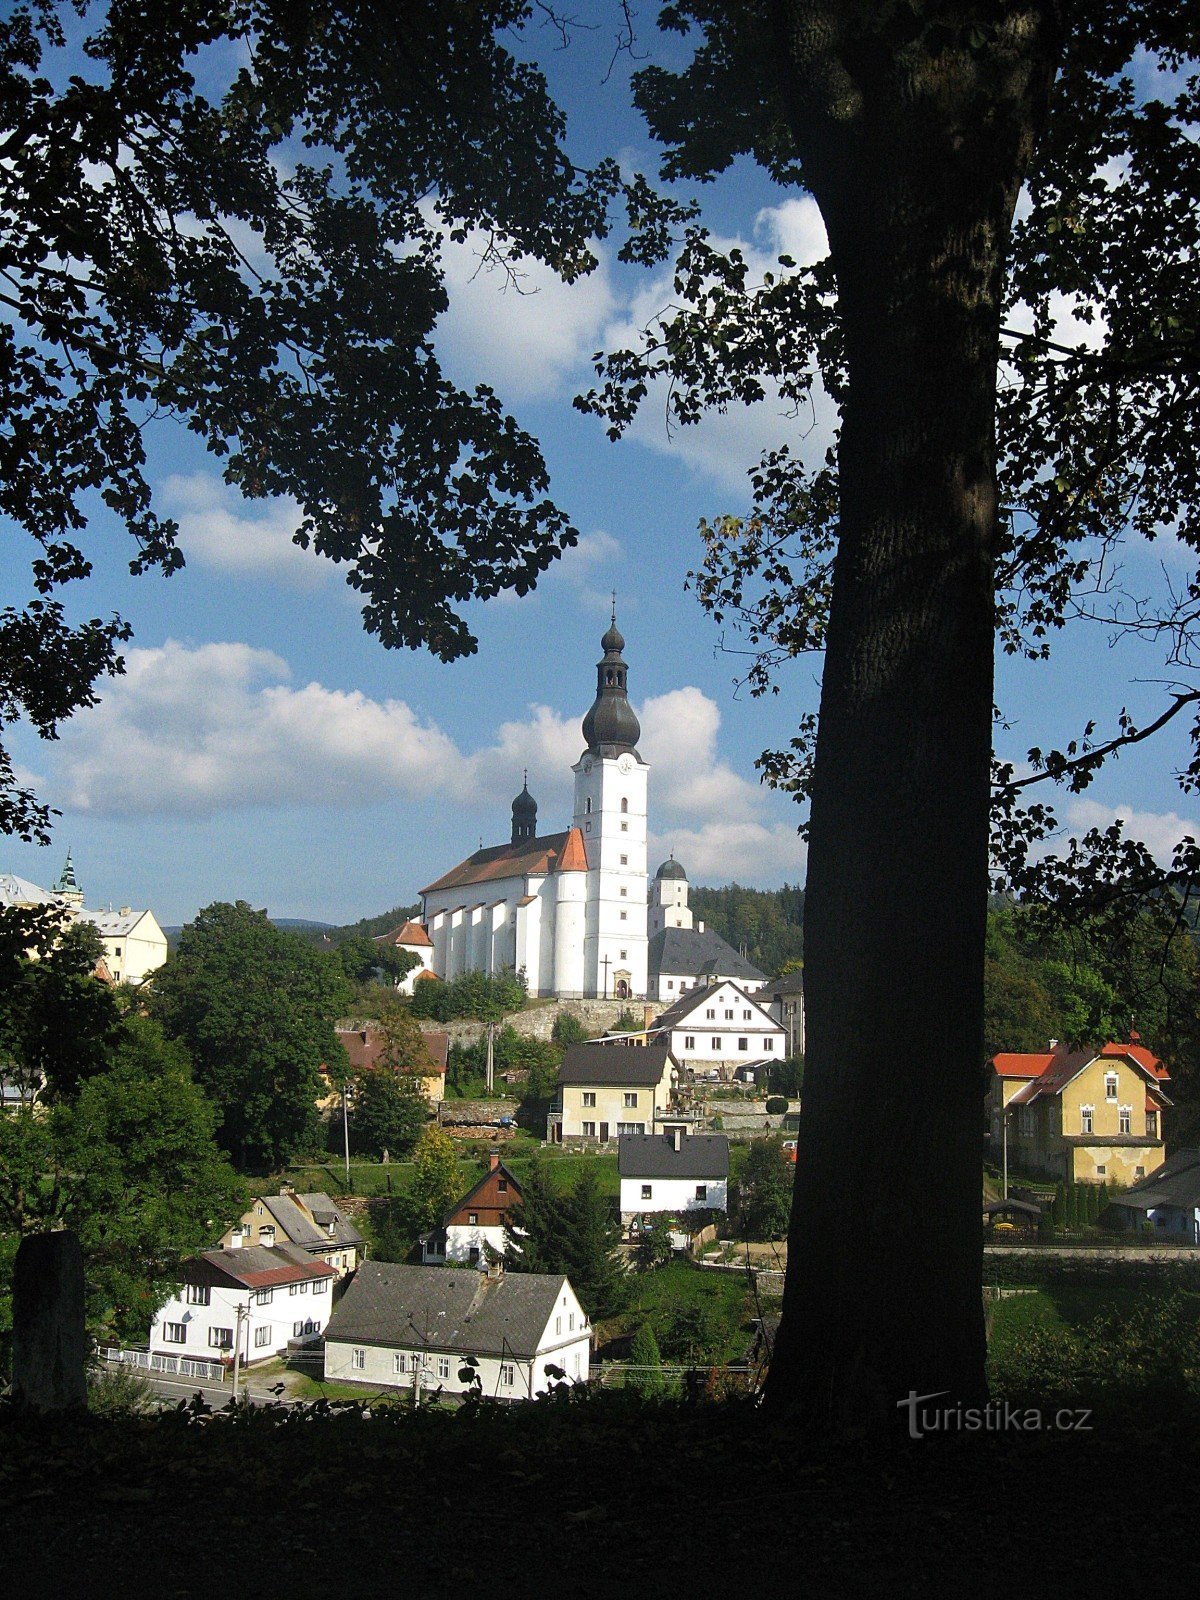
xmin=163 ymin=472 xmax=334 ymax=589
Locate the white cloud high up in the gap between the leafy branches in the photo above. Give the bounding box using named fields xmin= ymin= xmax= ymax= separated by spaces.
xmin=437 ymin=230 xmax=616 ymax=403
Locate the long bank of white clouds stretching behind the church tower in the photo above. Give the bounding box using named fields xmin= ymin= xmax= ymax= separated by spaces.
xmin=43 ymin=640 xmax=771 ymax=877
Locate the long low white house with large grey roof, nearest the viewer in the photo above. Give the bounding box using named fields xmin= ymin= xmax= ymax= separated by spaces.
xmin=325 ymin=1261 xmax=592 ymax=1400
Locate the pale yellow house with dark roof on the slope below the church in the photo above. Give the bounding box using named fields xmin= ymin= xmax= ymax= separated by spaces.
xmin=546 ymin=1043 xmax=678 ymax=1144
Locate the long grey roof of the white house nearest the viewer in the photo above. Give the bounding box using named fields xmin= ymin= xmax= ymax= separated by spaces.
xmin=325 ymin=1261 xmax=570 ymax=1357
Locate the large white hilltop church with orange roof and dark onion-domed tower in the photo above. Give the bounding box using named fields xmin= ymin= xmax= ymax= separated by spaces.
xmin=421 ymin=611 xmax=766 ymax=1000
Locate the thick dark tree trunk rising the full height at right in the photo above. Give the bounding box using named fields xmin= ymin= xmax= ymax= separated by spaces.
xmin=766 ymin=0 xmax=1058 ymax=1427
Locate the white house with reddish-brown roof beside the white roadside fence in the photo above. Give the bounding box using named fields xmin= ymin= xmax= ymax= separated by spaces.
xmin=150 ymin=1245 xmax=336 ymax=1366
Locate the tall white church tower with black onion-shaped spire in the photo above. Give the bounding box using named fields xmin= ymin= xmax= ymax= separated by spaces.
xmin=573 ymin=603 xmax=650 ymax=1000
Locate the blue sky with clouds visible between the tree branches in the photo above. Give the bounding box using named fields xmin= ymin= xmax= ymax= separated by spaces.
xmin=0 ymin=3 xmax=1200 ymax=923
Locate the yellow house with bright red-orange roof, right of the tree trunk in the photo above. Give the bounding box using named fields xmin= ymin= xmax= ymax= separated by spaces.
xmin=989 ymin=1034 xmax=1171 ymax=1186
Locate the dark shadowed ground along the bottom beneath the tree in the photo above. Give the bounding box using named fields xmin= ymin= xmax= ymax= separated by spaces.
xmin=0 ymin=1395 xmax=1200 ymax=1597
